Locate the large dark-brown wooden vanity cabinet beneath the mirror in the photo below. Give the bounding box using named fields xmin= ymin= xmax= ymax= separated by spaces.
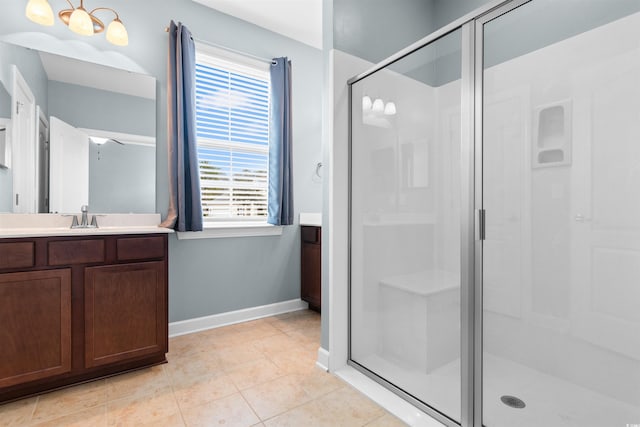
xmin=0 ymin=234 xmax=168 ymax=402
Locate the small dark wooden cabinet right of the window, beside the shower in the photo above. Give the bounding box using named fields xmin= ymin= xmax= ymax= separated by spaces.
xmin=300 ymin=226 xmax=322 ymax=312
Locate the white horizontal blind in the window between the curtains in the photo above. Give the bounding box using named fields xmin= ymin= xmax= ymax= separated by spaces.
xmin=196 ymin=52 xmax=269 ymax=221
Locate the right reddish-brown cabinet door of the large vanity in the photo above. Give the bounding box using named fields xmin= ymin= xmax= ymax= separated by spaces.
xmin=84 ymin=262 xmax=167 ymax=368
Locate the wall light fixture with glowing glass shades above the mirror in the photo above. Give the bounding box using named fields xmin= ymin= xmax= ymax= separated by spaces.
xmin=26 ymin=0 xmax=129 ymax=46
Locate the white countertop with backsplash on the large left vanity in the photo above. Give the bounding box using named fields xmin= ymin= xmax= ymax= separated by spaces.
xmin=0 ymin=213 xmax=173 ymax=238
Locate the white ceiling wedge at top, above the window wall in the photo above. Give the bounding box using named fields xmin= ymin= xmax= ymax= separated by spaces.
xmin=193 ymin=0 xmax=322 ymax=49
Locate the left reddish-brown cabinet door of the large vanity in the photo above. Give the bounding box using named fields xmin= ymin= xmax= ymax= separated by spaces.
xmin=0 ymin=269 xmax=71 ymax=387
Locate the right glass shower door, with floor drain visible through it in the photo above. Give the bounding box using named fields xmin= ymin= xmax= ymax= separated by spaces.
xmin=476 ymin=0 xmax=640 ymax=427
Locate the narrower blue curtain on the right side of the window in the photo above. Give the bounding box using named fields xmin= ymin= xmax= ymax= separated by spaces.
xmin=267 ymin=57 xmax=293 ymax=229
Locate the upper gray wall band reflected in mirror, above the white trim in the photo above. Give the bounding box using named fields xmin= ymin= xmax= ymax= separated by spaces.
xmin=49 ymin=81 xmax=156 ymax=136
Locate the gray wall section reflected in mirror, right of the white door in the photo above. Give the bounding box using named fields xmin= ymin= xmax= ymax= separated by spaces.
xmin=89 ymin=142 xmax=156 ymax=213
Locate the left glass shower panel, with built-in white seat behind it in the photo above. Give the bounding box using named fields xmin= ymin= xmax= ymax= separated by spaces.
xmin=350 ymin=29 xmax=462 ymax=423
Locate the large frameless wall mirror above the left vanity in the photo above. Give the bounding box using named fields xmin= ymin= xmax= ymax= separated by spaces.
xmin=0 ymin=42 xmax=156 ymax=213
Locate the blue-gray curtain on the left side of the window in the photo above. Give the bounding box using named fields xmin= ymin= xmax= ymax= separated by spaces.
xmin=162 ymin=21 xmax=202 ymax=231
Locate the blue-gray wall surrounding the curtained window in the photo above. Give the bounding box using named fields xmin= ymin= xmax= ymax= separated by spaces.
xmin=0 ymin=0 xmax=322 ymax=321
